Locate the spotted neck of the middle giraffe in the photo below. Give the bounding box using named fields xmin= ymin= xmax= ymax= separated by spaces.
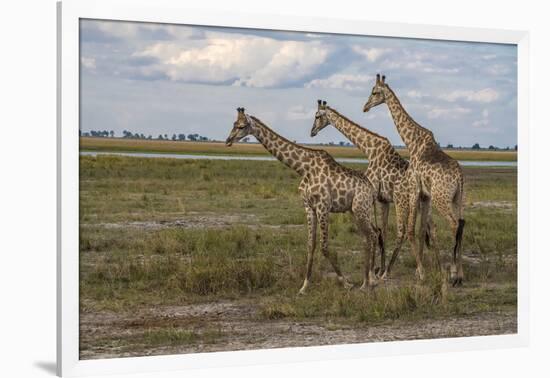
xmin=327 ymin=107 xmax=391 ymax=161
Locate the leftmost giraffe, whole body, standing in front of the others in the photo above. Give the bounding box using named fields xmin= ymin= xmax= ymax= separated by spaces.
xmin=226 ymin=108 xmax=383 ymax=294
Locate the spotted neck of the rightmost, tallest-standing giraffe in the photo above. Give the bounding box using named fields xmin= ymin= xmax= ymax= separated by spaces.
xmin=386 ymin=87 xmax=437 ymax=158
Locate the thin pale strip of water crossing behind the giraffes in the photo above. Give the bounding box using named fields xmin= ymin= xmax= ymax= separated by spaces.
xmin=80 ymin=151 xmax=517 ymax=167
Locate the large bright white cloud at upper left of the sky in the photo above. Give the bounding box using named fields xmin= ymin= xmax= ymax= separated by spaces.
xmin=136 ymin=36 xmax=329 ymax=87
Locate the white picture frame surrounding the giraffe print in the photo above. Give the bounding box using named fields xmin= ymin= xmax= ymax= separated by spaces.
xmin=57 ymin=0 xmax=529 ymax=376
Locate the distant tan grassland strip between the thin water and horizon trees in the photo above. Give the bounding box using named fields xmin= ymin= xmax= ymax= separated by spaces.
xmin=80 ymin=137 xmax=517 ymax=161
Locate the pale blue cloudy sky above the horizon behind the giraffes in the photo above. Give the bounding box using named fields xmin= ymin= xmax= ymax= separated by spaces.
xmin=80 ymin=20 xmax=517 ymax=147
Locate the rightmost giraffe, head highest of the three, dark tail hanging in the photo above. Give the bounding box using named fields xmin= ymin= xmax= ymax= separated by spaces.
xmin=363 ymin=74 xmax=466 ymax=286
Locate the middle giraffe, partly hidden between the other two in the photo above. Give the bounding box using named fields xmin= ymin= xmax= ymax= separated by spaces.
xmin=311 ymin=100 xmax=429 ymax=280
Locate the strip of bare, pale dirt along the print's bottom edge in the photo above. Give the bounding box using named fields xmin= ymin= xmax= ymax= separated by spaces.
xmin=80 ymin=299 xmax=517 ymax=359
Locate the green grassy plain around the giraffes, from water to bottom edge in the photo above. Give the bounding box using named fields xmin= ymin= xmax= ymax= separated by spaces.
xmin=80 ymin=155 xmax=517 ymax=358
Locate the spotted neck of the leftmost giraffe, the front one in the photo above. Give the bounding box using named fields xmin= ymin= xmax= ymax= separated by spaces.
xmin=250 ymin=116 xmax=315 ymax=176
